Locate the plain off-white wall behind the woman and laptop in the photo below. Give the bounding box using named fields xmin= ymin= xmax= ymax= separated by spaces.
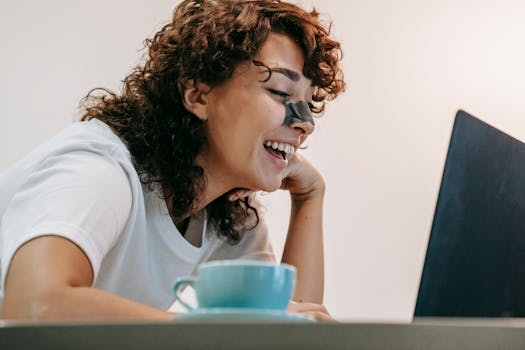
xmin=0 ymin=0 xmax=525 ymax=321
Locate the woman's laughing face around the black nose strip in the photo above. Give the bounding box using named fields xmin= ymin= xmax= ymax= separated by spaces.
xmin=197 ymin=33 xmax=313 ymax=191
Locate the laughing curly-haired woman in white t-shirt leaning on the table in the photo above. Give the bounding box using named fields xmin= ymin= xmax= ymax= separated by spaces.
xmin=0 ymin=0 xmax=344 ymax=320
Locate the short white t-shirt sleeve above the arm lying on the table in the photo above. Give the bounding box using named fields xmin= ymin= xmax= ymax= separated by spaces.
xmin=0 ymin=150 xmax=132 ymax=289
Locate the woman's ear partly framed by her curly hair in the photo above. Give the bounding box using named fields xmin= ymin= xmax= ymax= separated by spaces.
xmin=178 ymin=79 xmax=211 ymax=121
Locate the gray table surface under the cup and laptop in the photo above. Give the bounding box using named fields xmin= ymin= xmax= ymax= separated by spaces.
xmin=0 ymin=319 xmax=525 ymax=350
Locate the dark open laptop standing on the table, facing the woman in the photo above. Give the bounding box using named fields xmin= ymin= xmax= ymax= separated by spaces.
xmin=414 ymin=111 xmax=525 ymax=318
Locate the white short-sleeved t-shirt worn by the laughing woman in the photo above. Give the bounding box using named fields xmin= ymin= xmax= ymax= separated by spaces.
xmin=0 ymin=119 xmax=274 ymax=310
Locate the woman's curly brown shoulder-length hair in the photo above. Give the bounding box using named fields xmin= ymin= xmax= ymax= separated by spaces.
xmin=82 ymin=0 xmax=344 ymax=243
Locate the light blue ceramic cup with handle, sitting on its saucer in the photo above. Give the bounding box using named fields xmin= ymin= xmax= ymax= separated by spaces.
xmin=173 ymin=260 xmax=296 ymax=311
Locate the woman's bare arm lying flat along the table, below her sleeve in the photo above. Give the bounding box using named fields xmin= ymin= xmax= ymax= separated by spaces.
xmin=0 ymin=235 xmax=174 ymax=321
